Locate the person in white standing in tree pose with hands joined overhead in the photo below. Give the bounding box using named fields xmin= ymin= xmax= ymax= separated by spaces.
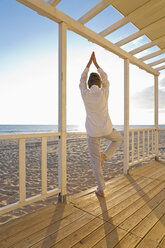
xmin=79 ymin=52 xmax=122 ymax=197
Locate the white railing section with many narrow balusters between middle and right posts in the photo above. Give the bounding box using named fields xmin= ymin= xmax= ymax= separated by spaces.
xmin=128 ymin=128 xmax=156 ymax=166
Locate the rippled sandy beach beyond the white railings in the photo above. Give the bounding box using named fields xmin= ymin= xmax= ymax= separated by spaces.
xmin=0 ymin=131 xmax=165 ymax=224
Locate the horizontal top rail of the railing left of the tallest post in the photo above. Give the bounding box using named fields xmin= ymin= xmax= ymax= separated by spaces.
xmin=0 ymin=132 xmax=61 ymax=140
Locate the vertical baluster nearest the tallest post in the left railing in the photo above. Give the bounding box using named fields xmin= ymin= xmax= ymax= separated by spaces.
xmin=41 ymin=137 xmax=47 ymax=195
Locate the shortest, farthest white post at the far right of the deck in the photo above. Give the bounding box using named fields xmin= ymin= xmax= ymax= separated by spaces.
xmin=154 ymin=75 xmax=159 ymax=160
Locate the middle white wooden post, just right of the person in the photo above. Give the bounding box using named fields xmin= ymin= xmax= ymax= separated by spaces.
xmin=123 ymin=59 xmax=129 ymax=174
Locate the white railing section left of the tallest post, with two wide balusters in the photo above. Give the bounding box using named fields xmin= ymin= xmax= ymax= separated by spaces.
xmin=0 ymin=133 xmax=61 ymax=215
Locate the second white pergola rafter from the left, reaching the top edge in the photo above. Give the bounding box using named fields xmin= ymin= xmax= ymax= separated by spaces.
xmin=78 ymin=0 xmax=114 ymax=24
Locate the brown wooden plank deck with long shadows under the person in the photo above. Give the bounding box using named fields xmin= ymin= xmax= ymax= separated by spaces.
xmin=0 ymin=161 xmax=165 ymax=248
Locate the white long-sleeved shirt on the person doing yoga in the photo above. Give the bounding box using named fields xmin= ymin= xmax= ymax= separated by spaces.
xmin=79 ymin=67 xmax=113 ymax=137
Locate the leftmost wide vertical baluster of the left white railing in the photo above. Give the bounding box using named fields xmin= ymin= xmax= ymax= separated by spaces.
xmin=19 ymin=139 xmax=26 ymax=203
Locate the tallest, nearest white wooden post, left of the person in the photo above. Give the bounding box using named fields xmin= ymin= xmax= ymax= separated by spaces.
xmin=58 ymin=22 xmax=67 ymax=202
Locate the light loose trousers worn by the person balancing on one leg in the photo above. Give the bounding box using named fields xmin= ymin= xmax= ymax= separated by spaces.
xmin=88 ymin=129 xmax=123 ymax=190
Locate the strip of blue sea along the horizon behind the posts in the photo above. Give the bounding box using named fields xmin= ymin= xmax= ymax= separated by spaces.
xmin=0 ymin=125 xmax=165 ymax=135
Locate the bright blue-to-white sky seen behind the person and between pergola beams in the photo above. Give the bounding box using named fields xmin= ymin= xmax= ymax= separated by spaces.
xmin=0 ymin=0 xmax=165 ymax=129
